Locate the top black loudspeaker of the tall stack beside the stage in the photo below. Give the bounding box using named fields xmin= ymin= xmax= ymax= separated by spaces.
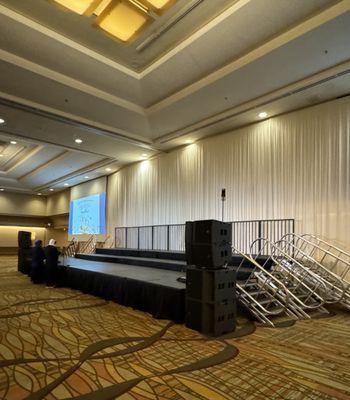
xmin=185 ymin=219 xmax=232 ymax=268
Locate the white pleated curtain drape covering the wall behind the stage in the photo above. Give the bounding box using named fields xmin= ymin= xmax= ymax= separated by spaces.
xmin=108 ymin=97 xmax=350 ymax=248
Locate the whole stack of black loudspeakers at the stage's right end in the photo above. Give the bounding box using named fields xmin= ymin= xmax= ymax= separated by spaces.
xmin=185 ymin=220 xmax=237 ymax=336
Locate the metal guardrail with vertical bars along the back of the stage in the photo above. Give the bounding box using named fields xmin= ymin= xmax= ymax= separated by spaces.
xmin=114 ymin=219 xmax=295 ymax=254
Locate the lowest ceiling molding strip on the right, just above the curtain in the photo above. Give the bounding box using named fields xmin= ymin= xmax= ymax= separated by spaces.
xmin=155 ymin=60 xmax=350 ymax=144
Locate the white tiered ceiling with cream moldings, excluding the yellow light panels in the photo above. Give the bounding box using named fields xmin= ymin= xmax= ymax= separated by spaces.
xmin=0 ymin=0 xmax=350 ymax=193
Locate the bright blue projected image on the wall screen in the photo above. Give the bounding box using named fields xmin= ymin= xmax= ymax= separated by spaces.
xmin=68 ymin=193 xmax=106 ymax=235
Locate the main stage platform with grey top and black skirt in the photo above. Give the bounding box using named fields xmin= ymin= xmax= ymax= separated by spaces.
xmin=65 ymin=254 xmax=186 ymax=322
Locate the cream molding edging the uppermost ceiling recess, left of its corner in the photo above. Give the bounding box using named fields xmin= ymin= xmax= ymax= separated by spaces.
xmin=0 ymin=5 xmax=139 ymax=79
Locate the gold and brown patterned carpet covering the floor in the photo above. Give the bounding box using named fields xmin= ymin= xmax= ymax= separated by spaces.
xmin=0 ymin=257 xmax=350 ymax=400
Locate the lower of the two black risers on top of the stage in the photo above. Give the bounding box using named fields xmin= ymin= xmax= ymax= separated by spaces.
xmin=75 ymin=253 xmax=186 ymax=272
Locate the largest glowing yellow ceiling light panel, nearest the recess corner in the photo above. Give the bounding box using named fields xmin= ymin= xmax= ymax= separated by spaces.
xmin=97 ymin=0 xmax=149 ymax=42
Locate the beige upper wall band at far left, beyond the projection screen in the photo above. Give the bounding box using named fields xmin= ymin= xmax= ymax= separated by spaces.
xmin=0 ymin=192 xmax=46 ymax=216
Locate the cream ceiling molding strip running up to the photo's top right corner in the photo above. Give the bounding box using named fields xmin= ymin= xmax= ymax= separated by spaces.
xmin=146 ymin=0 xmax=350 ymax=115
